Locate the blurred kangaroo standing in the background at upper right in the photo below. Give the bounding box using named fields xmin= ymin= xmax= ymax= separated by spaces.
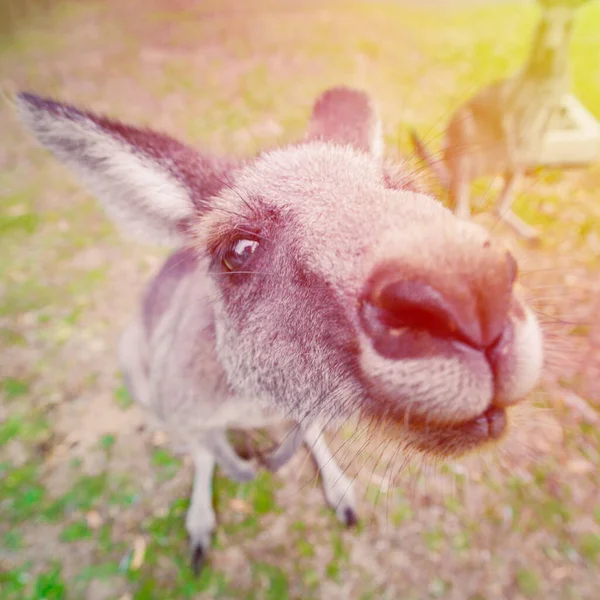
xmin=411 ymin=0 xmax=589 ymax=241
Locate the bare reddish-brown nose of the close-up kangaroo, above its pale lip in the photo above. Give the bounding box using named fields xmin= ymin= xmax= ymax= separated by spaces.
xmin=360 ymin=242 xmax=517 ymax=358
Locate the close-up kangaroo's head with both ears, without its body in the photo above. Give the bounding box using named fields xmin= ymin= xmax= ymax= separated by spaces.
xmin=18 ymin=88 xmax=542 ymax=456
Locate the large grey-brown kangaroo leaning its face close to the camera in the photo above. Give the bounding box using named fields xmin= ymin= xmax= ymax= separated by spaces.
xmin=17 ymin=87 xmax=543 ymax=570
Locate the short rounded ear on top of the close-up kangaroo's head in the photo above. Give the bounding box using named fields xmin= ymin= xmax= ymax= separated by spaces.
xmin=307 ymin=86 xmax=383 ymax=157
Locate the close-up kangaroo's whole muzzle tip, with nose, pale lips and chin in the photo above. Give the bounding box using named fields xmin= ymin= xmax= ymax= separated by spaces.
xmin=358 ymin=227 xmax=541 ymax=451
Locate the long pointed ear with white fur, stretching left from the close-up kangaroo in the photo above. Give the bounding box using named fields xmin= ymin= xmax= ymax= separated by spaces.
xmin=17 ymin=93 xmax=239 ymax=245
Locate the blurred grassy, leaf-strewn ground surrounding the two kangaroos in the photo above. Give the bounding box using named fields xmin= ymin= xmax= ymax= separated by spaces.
xmin=0 ymin=0 xmax=600 ymax=600
